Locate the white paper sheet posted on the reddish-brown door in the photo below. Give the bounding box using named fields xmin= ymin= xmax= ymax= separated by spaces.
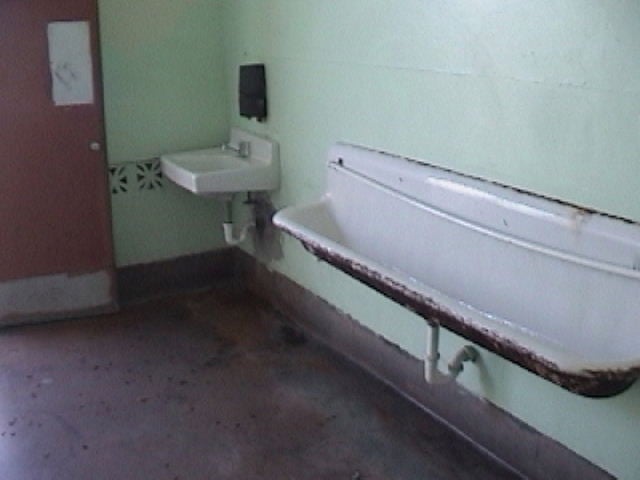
xmin=47 ymin=21 xmax=93 ymax=106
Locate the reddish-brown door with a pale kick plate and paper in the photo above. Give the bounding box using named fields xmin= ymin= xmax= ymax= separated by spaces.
xmin=0 ymin=0 xmax=115 ymax=324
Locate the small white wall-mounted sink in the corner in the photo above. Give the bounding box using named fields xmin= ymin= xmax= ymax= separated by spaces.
xmin=160 ymin=128 xmax=280 ymax=196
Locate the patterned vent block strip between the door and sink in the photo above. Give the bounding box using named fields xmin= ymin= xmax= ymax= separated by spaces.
xmin=109 ymin=158 xmax=164 ymax=195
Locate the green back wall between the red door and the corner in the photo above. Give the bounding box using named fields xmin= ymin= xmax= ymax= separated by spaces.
xmin=99 ymin=0 xmax=228 ymax=266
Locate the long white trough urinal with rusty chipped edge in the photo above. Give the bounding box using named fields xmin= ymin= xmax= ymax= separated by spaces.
xmin=274 ymin=144 xmax=640 ymax=397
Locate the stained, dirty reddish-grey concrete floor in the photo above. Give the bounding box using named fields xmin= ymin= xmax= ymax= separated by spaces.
xmin=0 ymin=291 xmax=517 ymax=480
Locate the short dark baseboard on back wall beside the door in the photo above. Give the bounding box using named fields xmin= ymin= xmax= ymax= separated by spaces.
xmin=118 ymin=248 xmax=237 ymax=305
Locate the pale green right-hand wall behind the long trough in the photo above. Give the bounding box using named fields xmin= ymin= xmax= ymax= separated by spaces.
xmin=223 ymin=0 xmax=640 ymax=479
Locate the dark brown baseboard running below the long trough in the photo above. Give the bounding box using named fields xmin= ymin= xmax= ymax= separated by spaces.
xmin=235 ymin=250 xmax=614 ymax=480
